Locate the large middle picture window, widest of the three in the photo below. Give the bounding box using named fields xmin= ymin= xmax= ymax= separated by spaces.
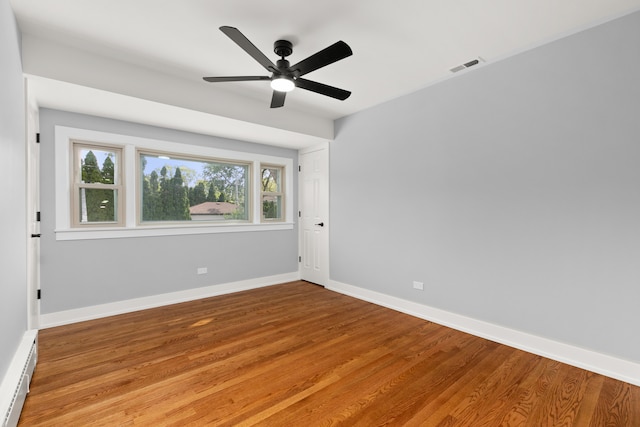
xmin=140 ymin=153 xmax=249 ymax=222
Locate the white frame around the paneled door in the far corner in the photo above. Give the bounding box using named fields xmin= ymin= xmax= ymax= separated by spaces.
xmin=298 ymin=141 xmax=331 ymax=287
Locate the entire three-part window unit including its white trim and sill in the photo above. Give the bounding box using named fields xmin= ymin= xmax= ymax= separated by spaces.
xmin=54 ymin=126 xmax=294 ymax=240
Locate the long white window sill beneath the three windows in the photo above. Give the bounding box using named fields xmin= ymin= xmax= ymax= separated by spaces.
xmin=55 ymin=222 xmax=293 ymax=240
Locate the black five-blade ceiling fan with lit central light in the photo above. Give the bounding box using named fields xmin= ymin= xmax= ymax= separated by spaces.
xmin=203 ymin=26 xmax=353 ymax=108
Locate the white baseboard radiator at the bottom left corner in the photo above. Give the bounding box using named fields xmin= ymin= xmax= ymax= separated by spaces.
xmin=0 ymin=330 xmax=38 ymax=427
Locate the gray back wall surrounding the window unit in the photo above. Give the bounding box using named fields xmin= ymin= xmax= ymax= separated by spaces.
xmin=40 ymin=109 xmax=298 ymax=314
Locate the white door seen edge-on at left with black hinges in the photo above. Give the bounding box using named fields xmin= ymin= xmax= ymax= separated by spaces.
xmin=25 ymin=80 xmax=40 ymax=329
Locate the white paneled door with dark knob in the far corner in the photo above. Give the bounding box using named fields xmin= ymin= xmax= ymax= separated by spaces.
xmin=298 ymin=144 xmax=329 ymax=286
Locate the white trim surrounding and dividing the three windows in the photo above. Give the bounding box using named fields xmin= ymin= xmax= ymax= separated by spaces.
xmin=54 ymin=126 xmax=294 ymax=240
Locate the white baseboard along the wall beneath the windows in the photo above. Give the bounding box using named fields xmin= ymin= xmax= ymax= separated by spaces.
xmin=40 ymin=271 xmax=300 ymax=329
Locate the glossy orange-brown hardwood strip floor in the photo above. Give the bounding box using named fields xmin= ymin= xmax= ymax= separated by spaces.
xmin=20 ymin=282 xmax=640 ymax=427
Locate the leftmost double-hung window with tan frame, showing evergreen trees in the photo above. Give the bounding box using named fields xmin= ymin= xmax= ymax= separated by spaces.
xmin=72 ymin=141 xmax=124 ymax=226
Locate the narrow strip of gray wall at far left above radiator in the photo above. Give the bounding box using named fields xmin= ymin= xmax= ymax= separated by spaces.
xmin=0 ymin=0 xmax=27 ymax=381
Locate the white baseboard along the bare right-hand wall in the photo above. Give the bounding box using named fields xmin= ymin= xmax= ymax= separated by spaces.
xmin=326 ymin=280 xmax=640 ymax=386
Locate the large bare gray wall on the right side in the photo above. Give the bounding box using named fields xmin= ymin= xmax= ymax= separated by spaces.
xmin=330 ymin=13 xmax=640 ymax=362
